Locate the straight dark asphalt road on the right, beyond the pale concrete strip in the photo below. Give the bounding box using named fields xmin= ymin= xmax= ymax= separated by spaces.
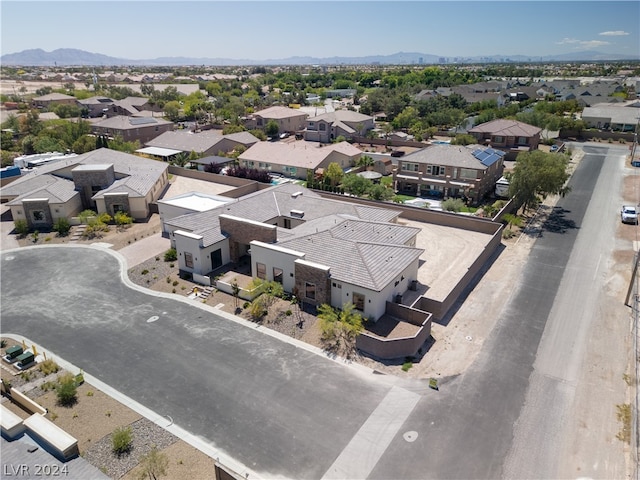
xmin=369 ymin=144 xmax=604 ymax=479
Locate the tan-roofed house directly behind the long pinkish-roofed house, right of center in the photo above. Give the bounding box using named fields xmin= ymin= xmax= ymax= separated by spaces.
xmin=304 ymin=110 xmax=375 ymax=143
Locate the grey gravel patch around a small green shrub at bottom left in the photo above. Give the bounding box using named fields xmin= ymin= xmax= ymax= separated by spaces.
xmin=83 ymin=418 xmax=178 ymax=479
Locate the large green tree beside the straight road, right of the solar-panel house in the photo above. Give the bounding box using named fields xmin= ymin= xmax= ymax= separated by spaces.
xmin=507 ymin=150 xmax=571 ymax=210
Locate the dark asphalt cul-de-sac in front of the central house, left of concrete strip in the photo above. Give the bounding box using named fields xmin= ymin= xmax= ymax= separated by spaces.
xmin=0 ymin=247 xmax=424 ymax=478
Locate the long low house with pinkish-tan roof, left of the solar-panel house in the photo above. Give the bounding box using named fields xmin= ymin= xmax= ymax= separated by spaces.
xmin=238 ymin=140 xmax=362 ymax=179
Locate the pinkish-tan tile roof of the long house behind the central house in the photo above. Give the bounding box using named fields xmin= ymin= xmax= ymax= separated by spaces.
xmin=238 ymin=140 xmax=362 ymax=169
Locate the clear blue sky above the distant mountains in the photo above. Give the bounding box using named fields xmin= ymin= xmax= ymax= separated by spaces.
xmin=0 ymin=0 xmax=640 ymax=60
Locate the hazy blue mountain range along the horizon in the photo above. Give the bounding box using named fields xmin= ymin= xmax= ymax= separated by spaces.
xmin=0 ymin=48 xmax=640 ymax=67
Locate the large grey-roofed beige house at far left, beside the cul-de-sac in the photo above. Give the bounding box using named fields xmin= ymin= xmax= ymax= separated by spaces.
xmin=0 ymin=148 xmax=169 ymax=229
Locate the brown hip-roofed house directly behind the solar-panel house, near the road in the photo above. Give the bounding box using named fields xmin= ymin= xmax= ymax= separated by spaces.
xmin=468 ymin=118 xmax=542 ymax=157
